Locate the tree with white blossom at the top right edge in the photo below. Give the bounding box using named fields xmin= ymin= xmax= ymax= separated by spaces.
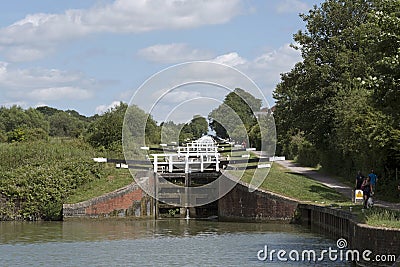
xmin=359 ymin=0 xmax=400 ymax=121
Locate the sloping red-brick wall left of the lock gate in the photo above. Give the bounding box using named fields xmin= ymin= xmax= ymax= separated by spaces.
xmin=63 ymin=183 xmax=154 ymax=219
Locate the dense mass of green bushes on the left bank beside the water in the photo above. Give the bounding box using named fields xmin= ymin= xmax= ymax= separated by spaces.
xmin=0 ymin=140 xmax=104 ymax=220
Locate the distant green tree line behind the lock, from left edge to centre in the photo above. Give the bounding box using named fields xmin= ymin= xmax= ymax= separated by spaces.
xmin=0 ymin=88 xmax=268 ymax=152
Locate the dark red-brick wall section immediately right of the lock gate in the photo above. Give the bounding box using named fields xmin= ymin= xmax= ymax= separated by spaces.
xmin=218 ymin=181 xmax=298 ymax=221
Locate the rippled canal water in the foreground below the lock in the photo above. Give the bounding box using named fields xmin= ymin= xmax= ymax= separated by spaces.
xmin=0 ymin=219 xmax=351 ymax=266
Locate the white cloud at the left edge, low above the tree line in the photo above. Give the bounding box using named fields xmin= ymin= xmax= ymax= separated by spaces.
xmin=0 ymin=62 xmax=98 ymax=102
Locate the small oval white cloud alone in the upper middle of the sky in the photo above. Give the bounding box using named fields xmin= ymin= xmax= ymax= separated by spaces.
xmin=138 ymin=43 xmax=212 ymax=63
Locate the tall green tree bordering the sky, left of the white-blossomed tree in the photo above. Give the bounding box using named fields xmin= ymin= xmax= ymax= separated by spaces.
xmin=275 ymin=0 xmax=370 ymax=149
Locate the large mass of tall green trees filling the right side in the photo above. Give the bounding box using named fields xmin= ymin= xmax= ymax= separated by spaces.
xmin=274 ymin=0 xmax=400 ymax=187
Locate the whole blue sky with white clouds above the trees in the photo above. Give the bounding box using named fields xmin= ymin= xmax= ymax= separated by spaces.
xmin=0 ymin=0 xmax=320 ymax=120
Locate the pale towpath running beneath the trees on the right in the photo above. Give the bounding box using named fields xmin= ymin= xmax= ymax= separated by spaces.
xmin=275 ymin=160 xmax=400 ymax=211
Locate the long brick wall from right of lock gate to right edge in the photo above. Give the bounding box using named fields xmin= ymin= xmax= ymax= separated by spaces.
xmin=218 ymin=178 xmax=400 ymax=266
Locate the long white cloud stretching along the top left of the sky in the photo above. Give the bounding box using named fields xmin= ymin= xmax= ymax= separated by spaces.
xmin=0 ymin=0 xmax=241 ymax=61
